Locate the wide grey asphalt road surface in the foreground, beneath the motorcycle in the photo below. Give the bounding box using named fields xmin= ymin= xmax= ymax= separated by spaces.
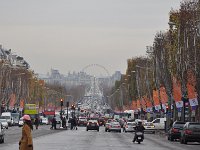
xmin=0 ymin=127 xmax=200 ymax=150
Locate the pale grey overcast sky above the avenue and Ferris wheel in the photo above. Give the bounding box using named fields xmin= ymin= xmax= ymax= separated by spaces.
xmin=0 ymin=0 xmax=181 ymax=74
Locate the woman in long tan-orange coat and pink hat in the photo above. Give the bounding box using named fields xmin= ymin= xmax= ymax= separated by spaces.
xmin=19 ymin=115 xmax=33 ymax=150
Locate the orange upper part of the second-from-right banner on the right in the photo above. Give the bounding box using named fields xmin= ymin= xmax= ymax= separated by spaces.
xmin=173 ymin=78 xmax=182 ymax=102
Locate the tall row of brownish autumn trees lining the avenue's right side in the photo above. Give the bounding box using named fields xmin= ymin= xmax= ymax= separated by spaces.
xmin=110 ymin=0 xmax=200 ymax=120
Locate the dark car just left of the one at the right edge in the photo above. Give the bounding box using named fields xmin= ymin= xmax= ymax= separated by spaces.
xmin=168 ymin=121 xmax=185 ymax=141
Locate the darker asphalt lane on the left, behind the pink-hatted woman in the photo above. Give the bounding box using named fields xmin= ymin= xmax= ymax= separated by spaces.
xmin=0 ymin=125 xmax=60 ymax=150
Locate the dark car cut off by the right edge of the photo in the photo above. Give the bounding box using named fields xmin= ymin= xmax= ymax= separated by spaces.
xmin=180 ymin=122 xmax=200 ymax=144
